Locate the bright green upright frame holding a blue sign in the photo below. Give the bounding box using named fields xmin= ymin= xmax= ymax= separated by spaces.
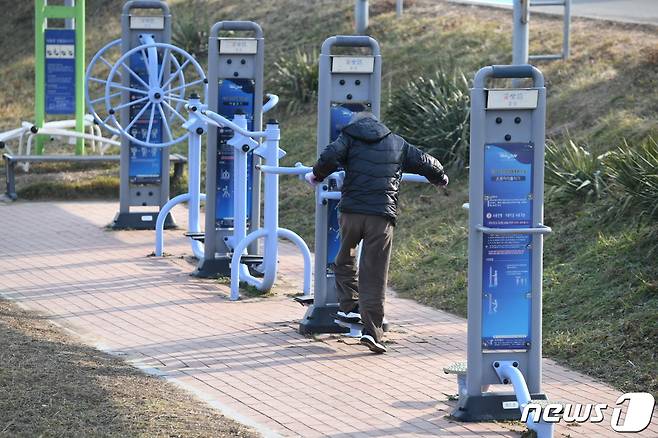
xmin=34 ymin=0 xmax=85 ymax=155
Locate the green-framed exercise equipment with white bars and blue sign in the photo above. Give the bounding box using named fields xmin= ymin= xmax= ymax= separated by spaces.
xmin=0 ymin=0 xmax=116 ymax=161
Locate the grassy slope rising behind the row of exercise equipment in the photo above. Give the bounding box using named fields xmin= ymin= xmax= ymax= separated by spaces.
xmin=0 ymin=0 xmax=658 ymax=393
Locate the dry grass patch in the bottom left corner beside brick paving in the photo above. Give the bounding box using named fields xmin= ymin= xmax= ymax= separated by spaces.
xmin=0 ymin=301 xmax=258 ymax=437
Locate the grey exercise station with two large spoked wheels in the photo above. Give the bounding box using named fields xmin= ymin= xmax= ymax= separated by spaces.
xmin=87 ymin=1 xmax=207 ymax=234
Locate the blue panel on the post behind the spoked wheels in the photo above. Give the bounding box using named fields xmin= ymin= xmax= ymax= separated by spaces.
xmin=128 ymin=53 xmax=162 ymax=184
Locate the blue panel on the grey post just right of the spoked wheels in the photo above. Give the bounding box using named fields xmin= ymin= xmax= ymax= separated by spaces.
xmin=215 ymin=79 xmax=255 ymax=228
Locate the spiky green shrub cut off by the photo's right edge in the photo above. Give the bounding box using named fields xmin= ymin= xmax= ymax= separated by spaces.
xmin=604 ymin=139 xmax=658 ymax=218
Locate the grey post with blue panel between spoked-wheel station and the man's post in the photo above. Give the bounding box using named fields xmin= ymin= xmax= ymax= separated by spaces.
xmin=195 ymin=21 xmax=266 ymax=277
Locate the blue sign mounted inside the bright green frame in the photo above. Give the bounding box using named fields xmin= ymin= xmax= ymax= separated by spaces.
xmin=44 ymin=29 xmax=75 ymax=114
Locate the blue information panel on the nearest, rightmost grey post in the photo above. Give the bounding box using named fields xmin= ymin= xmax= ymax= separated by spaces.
xmin=482 ymin=143 xmax=533 ymax=350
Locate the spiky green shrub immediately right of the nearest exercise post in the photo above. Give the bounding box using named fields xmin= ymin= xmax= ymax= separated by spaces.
xmin=544 ymin=140 xmax=606 ymax=201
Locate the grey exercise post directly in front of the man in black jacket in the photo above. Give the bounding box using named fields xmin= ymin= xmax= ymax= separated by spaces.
xmin=288 ymin=35 xmax=427 ymax=334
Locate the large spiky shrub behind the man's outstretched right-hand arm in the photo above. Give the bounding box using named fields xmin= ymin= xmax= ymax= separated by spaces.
xmin=386 ymin=71 xmax=470 ymax=168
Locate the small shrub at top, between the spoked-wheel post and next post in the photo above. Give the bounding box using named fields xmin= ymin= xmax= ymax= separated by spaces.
xmin=171 ymin=0 xmax=211 ymax=59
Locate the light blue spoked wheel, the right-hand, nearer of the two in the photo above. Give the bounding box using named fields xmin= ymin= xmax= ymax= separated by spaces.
xmin=96 ymin=43 xmax=208 ymax=147
